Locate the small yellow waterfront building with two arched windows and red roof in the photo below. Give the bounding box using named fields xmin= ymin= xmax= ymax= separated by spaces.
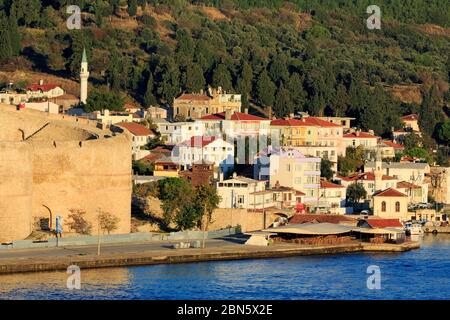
xmin=373 ymin=188 xmax=408 ymax=220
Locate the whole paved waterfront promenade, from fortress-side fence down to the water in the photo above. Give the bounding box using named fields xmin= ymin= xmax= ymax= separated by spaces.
xmin=0 ymin=237 xmax=419 ymax=274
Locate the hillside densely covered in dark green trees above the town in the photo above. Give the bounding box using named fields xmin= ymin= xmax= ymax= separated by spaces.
xmin=0 ymin=0 xmax=450 ymax=143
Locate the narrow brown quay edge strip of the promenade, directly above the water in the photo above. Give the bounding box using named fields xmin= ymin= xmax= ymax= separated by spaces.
xmin=0 ymin=242 xmax=420 ymax=274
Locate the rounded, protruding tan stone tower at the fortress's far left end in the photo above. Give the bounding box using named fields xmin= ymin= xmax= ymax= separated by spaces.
xmin=0 ymin=142 xmax=33 ymax=242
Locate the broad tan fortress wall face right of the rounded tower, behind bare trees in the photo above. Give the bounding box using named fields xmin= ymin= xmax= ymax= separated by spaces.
xmin=33 ymin=136 xmax=132 ymax=233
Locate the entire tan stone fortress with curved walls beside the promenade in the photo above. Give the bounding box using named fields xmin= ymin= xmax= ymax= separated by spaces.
xmin=0 ymin=106 xmax=132 ymax=242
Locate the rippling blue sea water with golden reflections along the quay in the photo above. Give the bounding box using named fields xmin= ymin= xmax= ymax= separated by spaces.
xmin=0 ymin=235 xmax=450 ymax=300
